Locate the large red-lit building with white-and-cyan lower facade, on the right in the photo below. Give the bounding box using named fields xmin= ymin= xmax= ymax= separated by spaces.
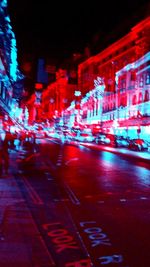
xmin=75 ymin=17 xmax=150 ymax=142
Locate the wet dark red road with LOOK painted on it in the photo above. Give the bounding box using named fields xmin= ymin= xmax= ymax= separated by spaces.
xmin=16 ymin=141 xmax=150 ymax=267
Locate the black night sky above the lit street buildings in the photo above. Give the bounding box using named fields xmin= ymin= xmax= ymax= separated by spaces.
xmin=8 ymin=0 xmax=149 ymax=64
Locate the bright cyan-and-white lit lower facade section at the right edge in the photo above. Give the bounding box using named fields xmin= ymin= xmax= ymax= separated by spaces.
xmin=113 ymin=52 xmax=150 ymax=139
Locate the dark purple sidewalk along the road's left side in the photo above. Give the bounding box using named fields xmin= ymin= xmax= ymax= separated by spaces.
xmin=0 ymin=151 xmax=55 ymax=267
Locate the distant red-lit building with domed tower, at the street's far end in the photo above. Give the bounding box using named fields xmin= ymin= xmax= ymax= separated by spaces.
xmin=27 ymin=69 xmax=77 ymax=125
